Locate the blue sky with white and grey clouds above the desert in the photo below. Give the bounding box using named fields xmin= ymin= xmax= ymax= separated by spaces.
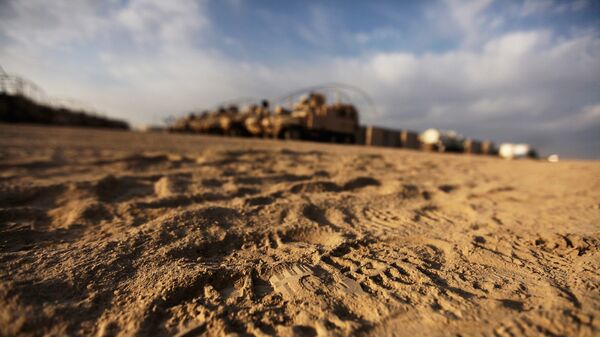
xmin=0 ymin=0 xmax=600 ymax=159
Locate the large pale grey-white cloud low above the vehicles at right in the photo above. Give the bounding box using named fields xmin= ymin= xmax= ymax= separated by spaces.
xmin=324 ymin=30 xmax=600 ymax=145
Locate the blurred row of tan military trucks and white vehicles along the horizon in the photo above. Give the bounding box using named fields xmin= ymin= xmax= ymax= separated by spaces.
xmin=169 ymin=85 xmax=535 ymax=159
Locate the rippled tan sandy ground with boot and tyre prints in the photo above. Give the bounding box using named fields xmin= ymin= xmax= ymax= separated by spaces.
xmin=0 ymin=125 xmax=600 ymax=336
